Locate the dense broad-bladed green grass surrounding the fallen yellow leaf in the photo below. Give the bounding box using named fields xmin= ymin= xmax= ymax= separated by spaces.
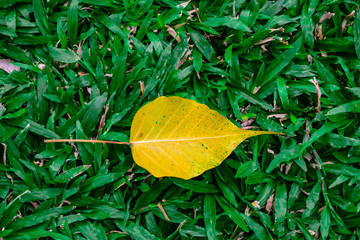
xmin=0 ymin=0 xmax=360 ymax=240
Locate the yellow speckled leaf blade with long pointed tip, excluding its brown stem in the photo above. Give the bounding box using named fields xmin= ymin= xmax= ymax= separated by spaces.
xmin=130 ymin=97 xmax=281 ymax=179
